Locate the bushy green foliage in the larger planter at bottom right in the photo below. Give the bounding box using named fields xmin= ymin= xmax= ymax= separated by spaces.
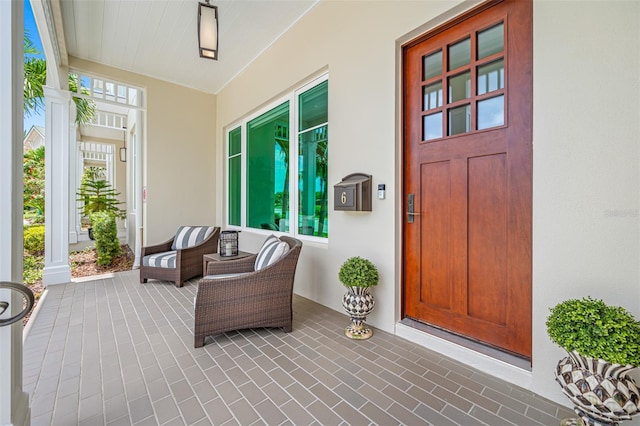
xmin=546 ymin=297 xmax=640 ymax=366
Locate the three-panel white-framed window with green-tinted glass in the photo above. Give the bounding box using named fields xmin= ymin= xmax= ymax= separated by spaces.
xmin=226 ymin=76 xmax=329 ymax=238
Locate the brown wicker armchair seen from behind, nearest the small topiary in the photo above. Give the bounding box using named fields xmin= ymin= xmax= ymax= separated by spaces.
xmin=193 ymin=236 xmax=302 ymax=348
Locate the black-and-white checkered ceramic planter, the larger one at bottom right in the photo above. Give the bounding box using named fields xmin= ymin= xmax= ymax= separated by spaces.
xmin=556 ymin=352 xmax=640 ymax=425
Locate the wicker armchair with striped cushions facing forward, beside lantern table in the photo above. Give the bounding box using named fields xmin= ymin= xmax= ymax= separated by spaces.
xmin=140 ymin=226 xmax=220 ymax=287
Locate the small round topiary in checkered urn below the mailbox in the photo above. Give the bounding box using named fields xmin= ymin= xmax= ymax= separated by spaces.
xmin=338 ymin=256 xmax=379 ymax=339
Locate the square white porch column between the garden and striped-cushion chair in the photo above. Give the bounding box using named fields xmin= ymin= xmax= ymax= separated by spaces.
xmin=42 ymin=87 xmax=76 ymax=286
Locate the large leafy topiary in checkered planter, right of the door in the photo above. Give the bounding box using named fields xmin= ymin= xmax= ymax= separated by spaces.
xmin=546 ymin=297 xmax=640 ymax=425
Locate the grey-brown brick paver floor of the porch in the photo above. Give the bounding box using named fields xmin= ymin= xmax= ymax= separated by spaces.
xmin=24 ymin=271 xmax=573 ymax=426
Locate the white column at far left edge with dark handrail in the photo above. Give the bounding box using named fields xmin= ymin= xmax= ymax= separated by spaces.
xmin=0 ymin=1 xmax=31 ymax=425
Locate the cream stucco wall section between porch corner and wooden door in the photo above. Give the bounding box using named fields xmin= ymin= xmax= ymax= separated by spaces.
xmin=216 ymin=1 xmax=458 ymax=332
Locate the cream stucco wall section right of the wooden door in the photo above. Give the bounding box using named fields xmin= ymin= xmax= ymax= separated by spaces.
xmin=533 ymin=1 xmax=640 ymax=406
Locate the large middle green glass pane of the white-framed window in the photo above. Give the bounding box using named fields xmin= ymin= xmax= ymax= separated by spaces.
xmin=246 ymin=102 xmax=290 ymax=232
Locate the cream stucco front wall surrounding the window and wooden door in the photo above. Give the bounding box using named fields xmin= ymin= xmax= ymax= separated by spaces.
xmin=215 ymin=1 xmax=640 ymax=410
